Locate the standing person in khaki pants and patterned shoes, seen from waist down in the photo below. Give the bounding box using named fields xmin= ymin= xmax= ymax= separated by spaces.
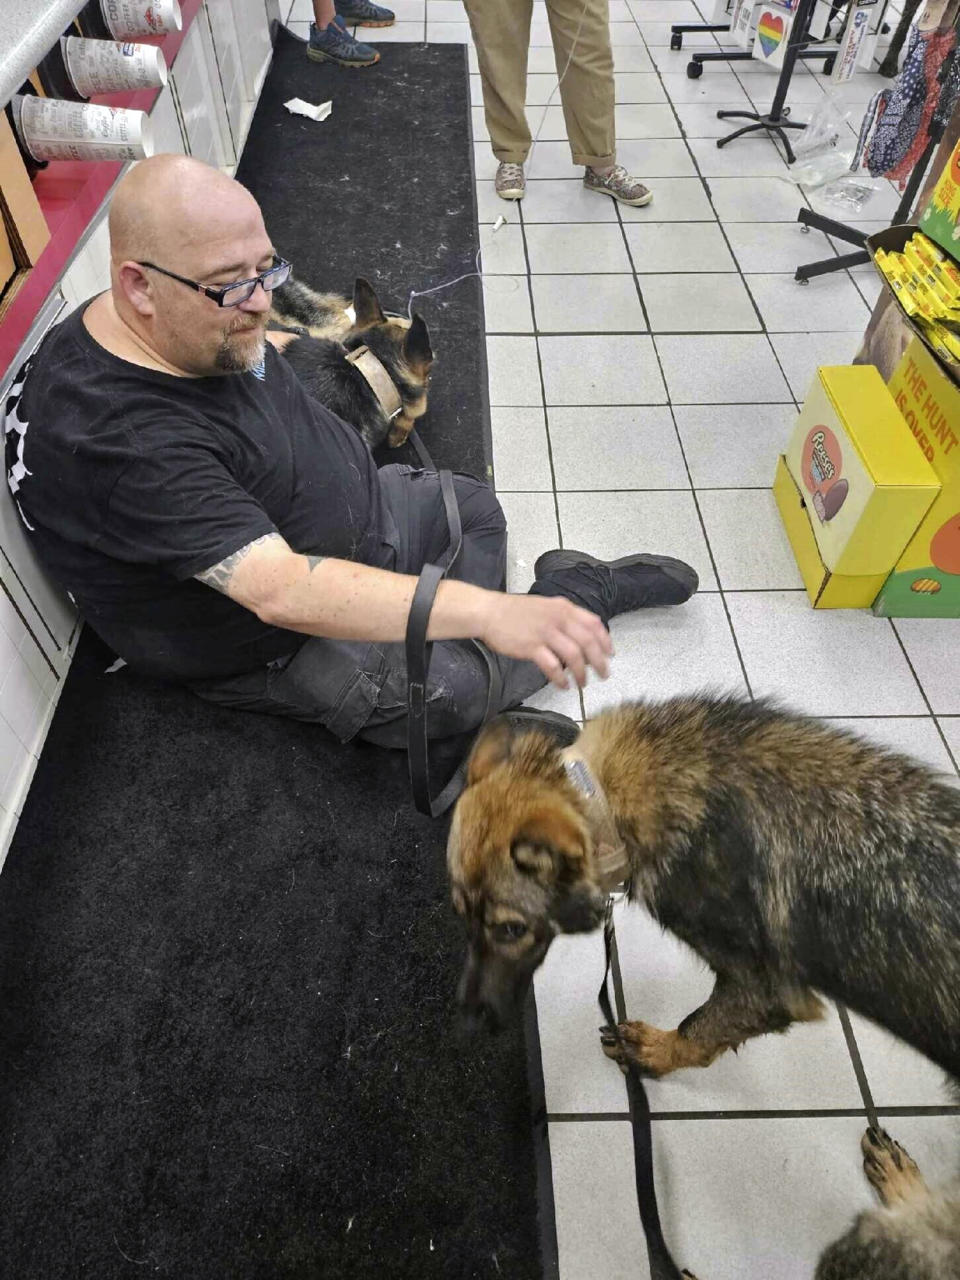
xmin=463 ymin=0 xmax=653 ymax=205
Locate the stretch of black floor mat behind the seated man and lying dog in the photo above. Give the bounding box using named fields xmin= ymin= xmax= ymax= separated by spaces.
xmin=237 ymin=31 xmax=490 ymax=477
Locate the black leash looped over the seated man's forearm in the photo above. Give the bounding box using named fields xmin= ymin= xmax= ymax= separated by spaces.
xmin=406 ymin=430 xmax=500 ymax=818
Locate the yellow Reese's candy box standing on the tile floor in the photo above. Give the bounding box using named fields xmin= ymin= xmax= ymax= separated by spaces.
xmin=773 ymin=365 xmax=940 ymax=609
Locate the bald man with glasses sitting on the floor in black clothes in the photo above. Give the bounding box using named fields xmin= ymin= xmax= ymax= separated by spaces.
xmin=5 ymin=155 xmax=696 ymax=746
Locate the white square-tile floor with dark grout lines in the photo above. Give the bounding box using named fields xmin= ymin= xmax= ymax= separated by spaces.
xmin=281 ymin=0 xmax=960 ymax=1280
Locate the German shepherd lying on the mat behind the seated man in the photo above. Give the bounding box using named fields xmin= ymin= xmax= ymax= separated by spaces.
xmin=270 ymin=276 xmax=434 ymax=449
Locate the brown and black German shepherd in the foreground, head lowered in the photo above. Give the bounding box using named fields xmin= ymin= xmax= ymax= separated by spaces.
xmin=448 ymin=698 xmax=960 ymax=1280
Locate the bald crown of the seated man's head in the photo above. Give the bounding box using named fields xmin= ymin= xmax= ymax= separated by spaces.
xmin=109 ymin=155 xmax=262 ymax=274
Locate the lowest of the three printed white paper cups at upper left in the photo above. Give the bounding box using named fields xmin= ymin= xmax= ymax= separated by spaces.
xmin=14 ymin=96 xmax=154 ymax=160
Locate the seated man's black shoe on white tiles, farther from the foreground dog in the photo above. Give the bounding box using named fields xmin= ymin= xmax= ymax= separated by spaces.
xmin=530 ymin=550 xmax=700 ymax=622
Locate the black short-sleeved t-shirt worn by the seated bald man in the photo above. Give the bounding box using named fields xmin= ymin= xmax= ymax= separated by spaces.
xmin=5 ymin=311 xmax=390 ymax=680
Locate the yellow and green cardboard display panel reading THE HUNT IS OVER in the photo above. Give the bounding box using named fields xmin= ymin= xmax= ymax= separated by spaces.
xmin=873 ymin=339 xmax=960 ymax=618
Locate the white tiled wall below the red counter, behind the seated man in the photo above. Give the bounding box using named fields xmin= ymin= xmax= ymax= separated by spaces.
xmin=0 ymin=0 xmax=270 ymax=863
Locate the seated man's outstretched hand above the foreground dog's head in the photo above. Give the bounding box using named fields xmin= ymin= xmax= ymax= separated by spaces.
xmin=477 ymin=591 xmax=613 ymax=689
